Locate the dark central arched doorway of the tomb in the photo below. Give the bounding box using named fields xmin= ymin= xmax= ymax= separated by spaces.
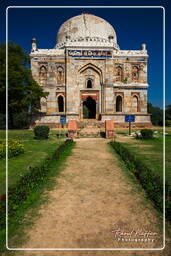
xmin=83 ymin=96 xmax=96 ymax=119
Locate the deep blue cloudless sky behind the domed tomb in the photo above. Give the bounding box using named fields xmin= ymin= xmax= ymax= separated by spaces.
xmin=0 ymin=0 xmax=171 ymax=107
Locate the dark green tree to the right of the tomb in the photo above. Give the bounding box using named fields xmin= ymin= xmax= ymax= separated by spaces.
xmin=147 ymin=103 xmax=163 ymax=126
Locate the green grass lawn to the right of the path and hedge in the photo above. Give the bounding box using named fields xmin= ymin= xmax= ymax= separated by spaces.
xmin=116 ymin=129 xmax=171 ymax=185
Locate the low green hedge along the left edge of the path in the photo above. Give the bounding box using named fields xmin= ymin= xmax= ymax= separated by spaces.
xmin=0 ymin=139 xmax=74 ymax=245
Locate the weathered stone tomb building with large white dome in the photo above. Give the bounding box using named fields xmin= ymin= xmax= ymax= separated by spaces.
xmin=30 ymin=13 xmax=151 ymax=127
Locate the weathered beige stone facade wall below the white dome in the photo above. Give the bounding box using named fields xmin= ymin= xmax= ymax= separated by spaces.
xmin=31 ymin=49 xmax=148 ymax=122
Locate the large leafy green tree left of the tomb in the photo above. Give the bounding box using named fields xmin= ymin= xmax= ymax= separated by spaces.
xmin=0 ymin=42 xmax=47 ymax=128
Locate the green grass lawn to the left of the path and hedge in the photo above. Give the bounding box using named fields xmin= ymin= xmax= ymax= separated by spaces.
xmin=0 ymin=130 xmax=63 ymax=194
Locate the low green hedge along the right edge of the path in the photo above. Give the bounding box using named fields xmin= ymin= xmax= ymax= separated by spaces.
xmin=110 ymin=142 xmax=171 ymax=221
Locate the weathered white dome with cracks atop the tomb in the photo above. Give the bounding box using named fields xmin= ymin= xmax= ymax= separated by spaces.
xmin=56 ymin=13 xmax=118 ymax=49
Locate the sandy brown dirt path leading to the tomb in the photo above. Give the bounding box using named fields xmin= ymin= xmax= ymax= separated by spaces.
xmin=14 ymin=139 xmax=166 ymax=256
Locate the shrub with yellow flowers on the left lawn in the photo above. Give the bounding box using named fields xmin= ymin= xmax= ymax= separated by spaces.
xmin=0 ymin=139 xmax=24 ymax=158
